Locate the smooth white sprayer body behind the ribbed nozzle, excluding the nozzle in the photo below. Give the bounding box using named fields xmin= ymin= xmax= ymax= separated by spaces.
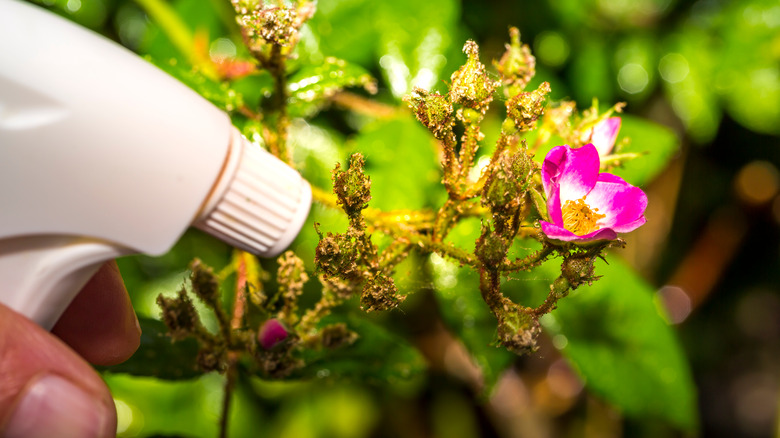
xmin=0 ymin=0 xmax=231 ymax=254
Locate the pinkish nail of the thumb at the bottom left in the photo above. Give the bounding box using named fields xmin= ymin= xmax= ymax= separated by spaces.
xmin=0 ymin=375 xmax=114 ymax=438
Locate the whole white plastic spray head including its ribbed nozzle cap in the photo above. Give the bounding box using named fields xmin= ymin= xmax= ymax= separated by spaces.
xmin=0 ymin=0 xmax=311 ymax=329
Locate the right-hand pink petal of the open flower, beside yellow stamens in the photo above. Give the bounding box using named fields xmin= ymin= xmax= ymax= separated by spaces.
xmin=585 ymin=173 xmax=647 ymax=233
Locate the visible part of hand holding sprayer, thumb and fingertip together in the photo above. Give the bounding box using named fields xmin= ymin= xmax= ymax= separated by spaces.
xmin=0 ymin=261 xmax=141 ymax=438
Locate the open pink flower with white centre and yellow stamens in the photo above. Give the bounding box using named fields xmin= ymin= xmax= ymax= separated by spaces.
xmin=540 ymin=144 xmax=647 ymax=243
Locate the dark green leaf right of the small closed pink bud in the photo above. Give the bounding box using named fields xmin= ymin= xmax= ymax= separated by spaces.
xmin=294 ymin=316 xmax=427 ymax=385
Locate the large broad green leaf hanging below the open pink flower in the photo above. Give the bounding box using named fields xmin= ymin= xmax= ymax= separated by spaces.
xmin=537 ymin=257 xmax=698 ymax=431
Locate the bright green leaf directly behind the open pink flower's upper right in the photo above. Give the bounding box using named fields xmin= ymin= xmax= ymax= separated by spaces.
xmin=609 ymin=114 xmax=680 ymax=186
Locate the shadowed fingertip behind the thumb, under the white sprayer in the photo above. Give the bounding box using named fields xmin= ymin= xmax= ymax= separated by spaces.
xmin=52 ymin=261 xmax=141 ymax=365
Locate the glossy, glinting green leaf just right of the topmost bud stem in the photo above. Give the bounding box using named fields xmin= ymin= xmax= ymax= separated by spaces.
xmin=287 ymin=58 xmax=375 ymax=117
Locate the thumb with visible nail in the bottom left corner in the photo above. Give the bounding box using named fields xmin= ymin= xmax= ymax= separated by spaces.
xmin=0 ymin=305 xmax=116 ymax=438
